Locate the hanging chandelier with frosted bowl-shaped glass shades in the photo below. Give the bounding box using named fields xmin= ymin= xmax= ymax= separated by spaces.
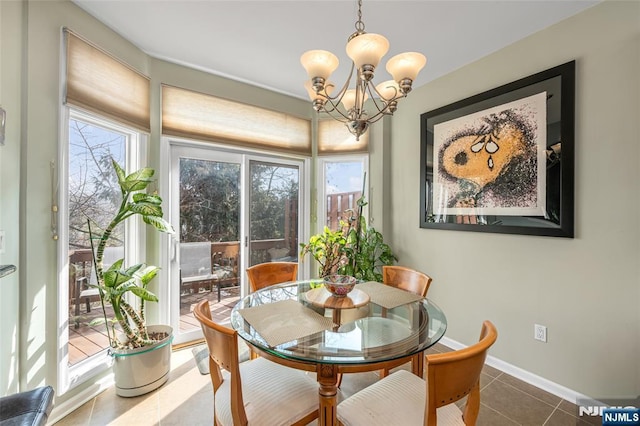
xmin=300 ymin=0 xmax=427 ymax=140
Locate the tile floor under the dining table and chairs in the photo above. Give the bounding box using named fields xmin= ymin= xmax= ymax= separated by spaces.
xmin=56 ymin=344 xmax=601 ymax=426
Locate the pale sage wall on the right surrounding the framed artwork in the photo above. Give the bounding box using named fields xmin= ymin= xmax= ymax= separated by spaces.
xmin=389 ymin=1 xmax=640 ymax=398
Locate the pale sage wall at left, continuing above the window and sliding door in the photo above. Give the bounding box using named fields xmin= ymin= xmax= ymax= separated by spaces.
xmin=0 ymin=0 xmax=312 ymax=410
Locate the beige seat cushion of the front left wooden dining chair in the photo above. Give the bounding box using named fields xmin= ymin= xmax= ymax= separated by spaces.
xmin=214 ymin=358 xmax=318 ymax=426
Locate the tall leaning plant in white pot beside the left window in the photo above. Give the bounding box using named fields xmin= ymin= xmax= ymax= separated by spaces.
xmin=89 ymin=160 xmax=173 ymax=396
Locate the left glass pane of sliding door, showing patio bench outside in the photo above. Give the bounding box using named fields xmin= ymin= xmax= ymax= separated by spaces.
xmin=176 ymin=157 xmax=241 ymax=334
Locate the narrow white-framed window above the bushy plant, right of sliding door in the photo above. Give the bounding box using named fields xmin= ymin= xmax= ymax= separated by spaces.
xmin=318 ymin=155 xmax=368 ymax=230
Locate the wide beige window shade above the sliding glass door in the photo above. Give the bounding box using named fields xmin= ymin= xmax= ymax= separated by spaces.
xmin=162 ymin=85 xmax=311 ymax=155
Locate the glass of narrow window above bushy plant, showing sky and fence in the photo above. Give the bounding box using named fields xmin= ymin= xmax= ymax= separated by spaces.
xmin=324 ymin=161 xmax=364 ymax=230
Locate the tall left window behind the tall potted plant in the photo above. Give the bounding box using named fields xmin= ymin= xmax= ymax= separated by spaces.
xmin=59 ymin=109 xmax=144 ymax=390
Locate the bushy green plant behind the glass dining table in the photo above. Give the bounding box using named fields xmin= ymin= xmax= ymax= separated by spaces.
xmin=300 ymin=196 xmax=398 ymax=282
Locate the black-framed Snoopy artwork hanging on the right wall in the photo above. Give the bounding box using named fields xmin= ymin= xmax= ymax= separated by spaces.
xmin=420 ymin=61 xmax=575 ymax=238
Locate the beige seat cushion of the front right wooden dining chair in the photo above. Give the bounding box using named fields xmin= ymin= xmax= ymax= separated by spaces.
xmin=338 ymin=370 xmax=464 ymax=426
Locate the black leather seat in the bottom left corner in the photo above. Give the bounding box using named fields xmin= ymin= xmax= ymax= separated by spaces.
xmin=0 ymin=386 xmax=54 ymax=426
